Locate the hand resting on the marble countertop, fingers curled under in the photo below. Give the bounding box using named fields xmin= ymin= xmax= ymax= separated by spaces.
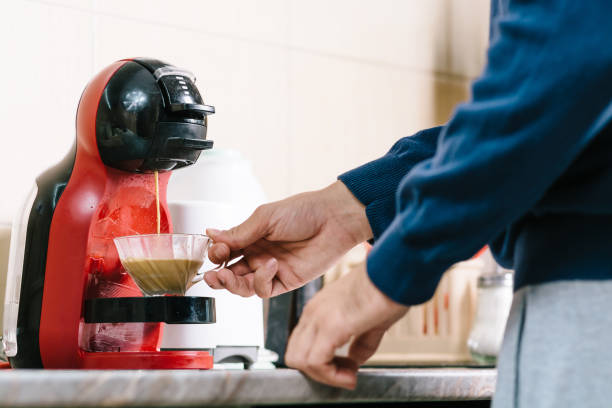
xmin=285 ymin=265 xmax=408 ymax=389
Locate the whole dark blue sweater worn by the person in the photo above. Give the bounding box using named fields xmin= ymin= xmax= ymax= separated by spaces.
xmin=339 ymin=0 xmax=612 ymax=305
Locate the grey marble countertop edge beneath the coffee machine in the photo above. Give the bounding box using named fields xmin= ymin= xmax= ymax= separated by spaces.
xmin=0 ymin=368 xmax=496 ymax=407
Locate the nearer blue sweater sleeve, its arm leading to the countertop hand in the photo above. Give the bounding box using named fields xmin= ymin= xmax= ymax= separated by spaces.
xmin=367 ymin=0 xmax=612 ymax=305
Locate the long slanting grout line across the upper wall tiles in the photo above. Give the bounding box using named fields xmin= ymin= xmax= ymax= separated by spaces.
xmin=25 ymin=0 xmax=475 ymax=83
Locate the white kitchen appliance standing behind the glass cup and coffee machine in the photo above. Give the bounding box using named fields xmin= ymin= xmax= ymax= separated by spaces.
xmin=162 ymin=150 xmax=265 ymax=366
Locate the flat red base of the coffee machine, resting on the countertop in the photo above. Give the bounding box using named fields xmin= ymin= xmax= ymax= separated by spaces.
xmin=82 ymin=350 xmax=213 ymax=370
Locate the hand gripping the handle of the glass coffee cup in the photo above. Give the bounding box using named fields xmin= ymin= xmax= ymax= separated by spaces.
xmin=204 ymin=181 xmax=372 ymax=298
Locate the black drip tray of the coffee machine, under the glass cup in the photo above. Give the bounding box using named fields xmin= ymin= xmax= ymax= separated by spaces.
xmin=84 ymin=296 xmax=216 ymax=324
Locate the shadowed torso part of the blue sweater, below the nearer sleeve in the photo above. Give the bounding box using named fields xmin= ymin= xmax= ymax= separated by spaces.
xmin=489 ymin=0 xmax=612 ymax=289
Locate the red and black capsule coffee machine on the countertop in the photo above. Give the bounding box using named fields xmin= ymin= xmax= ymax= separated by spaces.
xmin=3 ymin=58 xmax=215 ymax=369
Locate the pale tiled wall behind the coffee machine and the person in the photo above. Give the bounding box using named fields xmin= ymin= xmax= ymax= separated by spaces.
xmin=0 ymin=0 xmax=489 ymax=221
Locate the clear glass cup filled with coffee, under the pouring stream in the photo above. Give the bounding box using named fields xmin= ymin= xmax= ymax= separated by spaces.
xmin=114 ymin=234 xmax=226 ymax=296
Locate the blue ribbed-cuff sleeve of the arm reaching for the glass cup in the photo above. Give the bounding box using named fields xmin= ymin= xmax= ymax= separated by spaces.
xmin=338 ymin=127 xmax=441 ymax=240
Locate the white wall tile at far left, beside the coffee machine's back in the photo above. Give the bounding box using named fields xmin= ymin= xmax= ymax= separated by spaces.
xmin=0 ymin=1 xmax=93 ymax=221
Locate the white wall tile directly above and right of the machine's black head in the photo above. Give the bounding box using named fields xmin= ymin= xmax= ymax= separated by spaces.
xmin=95 ymin=16 xmax=289 ymax=199
